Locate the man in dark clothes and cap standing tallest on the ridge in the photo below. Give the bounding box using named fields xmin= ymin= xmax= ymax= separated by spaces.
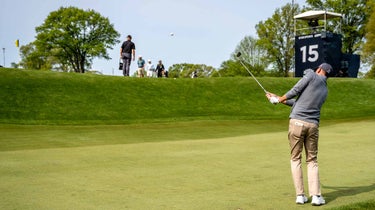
xmin=120 ymin=35 xmax=135 ymax=77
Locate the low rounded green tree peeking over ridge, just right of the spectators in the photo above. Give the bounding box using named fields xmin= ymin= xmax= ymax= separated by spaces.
xmin=168 ymin=63 xmax=216 ymax=78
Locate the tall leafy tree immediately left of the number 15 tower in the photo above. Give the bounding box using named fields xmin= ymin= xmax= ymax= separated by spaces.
xmin=256 ymin=4 xmax=299 ymax=77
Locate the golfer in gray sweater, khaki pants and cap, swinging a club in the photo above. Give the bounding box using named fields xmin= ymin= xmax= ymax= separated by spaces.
xmin=266 ymin=63 xmax=333 ymax=206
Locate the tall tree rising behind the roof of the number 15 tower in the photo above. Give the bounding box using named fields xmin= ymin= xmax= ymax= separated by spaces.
xmin=306 ymin=0 xmax=373 ymax=54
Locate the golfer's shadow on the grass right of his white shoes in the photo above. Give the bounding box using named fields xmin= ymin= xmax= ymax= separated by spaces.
xmin=322 ymin=183 xmax=375 ymax=202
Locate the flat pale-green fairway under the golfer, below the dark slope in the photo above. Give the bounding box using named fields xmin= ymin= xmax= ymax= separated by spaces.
xmin=0 ymin=120 xmax=375 ymax=210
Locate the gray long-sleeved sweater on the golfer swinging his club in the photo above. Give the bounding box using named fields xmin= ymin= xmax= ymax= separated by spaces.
xmin=285 ymin=69 xmax=328 ymax=125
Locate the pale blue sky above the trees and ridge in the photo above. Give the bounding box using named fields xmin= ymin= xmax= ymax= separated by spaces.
xmin=0 ymin=0 xmax=305 ymax=75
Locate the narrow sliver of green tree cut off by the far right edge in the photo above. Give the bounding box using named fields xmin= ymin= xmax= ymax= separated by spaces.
xmin=363 ymin=3 xmax=375 ymax=78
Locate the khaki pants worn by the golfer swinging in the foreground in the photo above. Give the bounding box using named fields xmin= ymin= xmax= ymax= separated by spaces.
xmin=288 ymin=119 xmax=321 ymax=196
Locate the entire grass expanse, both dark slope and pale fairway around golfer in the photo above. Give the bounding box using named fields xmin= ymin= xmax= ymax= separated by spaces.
xmin=0 ymin=69 xmax=375 ymax=210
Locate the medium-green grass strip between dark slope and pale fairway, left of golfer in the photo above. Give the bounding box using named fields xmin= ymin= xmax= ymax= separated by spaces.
xmin=0 ymin=120 xmax=287 ymax=151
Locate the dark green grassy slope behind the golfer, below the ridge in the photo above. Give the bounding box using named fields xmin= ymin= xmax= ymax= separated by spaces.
xmin=0 ymin=69 xmax=375 ymax=124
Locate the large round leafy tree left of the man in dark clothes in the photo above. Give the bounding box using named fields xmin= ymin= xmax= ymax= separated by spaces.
xmin=35 ymin=7 xmax=120 ymax=73
